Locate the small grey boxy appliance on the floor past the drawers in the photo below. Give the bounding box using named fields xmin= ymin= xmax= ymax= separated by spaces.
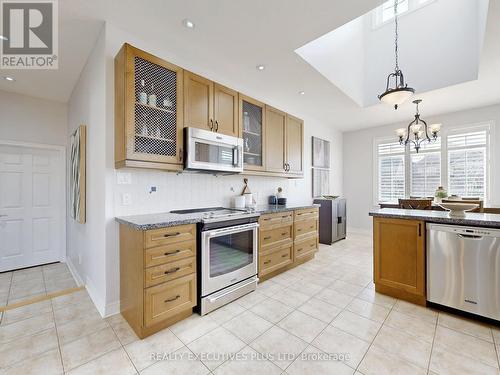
xmin=314 ymin=198 xmax=346 ymax=245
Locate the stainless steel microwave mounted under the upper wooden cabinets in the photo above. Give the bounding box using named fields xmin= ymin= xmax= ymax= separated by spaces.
xmin=184 ymin=128 xmax=243 ymax=173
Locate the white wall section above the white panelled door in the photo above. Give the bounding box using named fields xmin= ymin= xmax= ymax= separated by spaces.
xmin=0 ymin=89 xmax=68 ymax=146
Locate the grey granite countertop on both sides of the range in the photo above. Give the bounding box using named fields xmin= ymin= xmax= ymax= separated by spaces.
xmin=115 ymin=204 xmax=319 ymax=230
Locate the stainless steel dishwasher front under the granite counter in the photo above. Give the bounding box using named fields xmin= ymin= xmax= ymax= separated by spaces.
xmin=427 ymin=224 xmax=500 ymax=320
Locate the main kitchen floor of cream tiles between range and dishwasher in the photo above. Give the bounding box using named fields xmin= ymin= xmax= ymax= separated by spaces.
xmin=0 ymin=234 xmax=500 ymax=375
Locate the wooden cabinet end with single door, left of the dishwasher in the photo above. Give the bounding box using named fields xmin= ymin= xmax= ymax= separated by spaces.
xmin=373 ymin=217 xmax=426 ymax=306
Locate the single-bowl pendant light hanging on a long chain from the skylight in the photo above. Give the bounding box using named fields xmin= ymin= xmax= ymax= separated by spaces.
xmin=378 ymin=0 xmax=415 ymax=109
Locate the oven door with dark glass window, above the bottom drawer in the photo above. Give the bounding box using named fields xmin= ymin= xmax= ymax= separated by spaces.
xmin=201 ymin=223 xmax=259 ymax=296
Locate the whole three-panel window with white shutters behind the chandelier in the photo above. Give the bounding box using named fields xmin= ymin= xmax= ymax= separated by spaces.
xmin=373 ymin=124 xmax=492 ymax=204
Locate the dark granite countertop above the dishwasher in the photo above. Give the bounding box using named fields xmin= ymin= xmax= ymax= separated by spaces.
xmin=370 ymin=208 xmax=500 ymax=228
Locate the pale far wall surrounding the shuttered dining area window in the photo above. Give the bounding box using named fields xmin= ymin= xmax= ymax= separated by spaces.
xmin=343 ymin=105 xmax=500 ymax=230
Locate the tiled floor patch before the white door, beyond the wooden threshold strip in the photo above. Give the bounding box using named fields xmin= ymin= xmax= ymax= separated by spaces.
xmin=0 ymin=263 xmax=77 ymax=306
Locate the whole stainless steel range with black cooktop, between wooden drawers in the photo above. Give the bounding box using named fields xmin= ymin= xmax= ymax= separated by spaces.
xmin=172 ymin=207 xmax=259 ymax=315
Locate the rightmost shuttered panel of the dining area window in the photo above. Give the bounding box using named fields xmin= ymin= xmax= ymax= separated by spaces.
xmin=448 ymin=130 xmax=488 ymax=199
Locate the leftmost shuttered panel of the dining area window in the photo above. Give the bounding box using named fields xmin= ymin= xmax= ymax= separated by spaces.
xmin=377 ymin=142 xmax=405 ymax=202
